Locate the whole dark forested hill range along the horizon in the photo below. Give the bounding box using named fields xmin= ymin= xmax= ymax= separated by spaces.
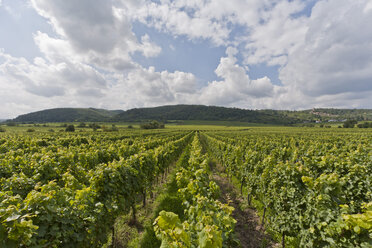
xmin=13 ymin=105 xmax=372 ymax=124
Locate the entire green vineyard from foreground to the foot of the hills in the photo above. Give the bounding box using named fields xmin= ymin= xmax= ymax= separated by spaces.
xmin=0 ymin=127 xmax=372 ymax=248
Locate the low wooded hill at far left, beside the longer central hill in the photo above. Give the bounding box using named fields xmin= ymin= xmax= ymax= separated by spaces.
xmin=14 ymin=108 xmax=123 ymax=122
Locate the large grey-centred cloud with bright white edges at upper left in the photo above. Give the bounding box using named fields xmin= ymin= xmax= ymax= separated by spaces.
xmin=32 ymin=0 xmax=161 ymax=71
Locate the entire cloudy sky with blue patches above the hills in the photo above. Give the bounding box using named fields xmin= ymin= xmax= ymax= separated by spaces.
xmin=0 ymin=0 xmax=372 ymax=119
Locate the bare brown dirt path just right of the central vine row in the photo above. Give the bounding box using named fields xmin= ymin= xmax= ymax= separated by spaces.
xmin=213 ymin=165 xmax=279 ymax=248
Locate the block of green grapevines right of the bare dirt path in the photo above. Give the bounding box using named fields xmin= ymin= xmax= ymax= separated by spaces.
xmin=204 ymin=132 xmax=372 ymax=247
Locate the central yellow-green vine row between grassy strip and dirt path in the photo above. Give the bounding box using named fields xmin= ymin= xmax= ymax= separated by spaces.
xmin=154 ymin=135 xmax=236 ymax=248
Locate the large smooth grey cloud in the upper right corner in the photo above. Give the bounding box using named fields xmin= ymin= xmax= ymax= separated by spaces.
xmin=280 ymin=0 xmax=372 ymax=97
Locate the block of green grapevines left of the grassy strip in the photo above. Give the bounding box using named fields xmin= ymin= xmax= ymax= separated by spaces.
xmin=0 ymin=133 xmax=192 ymax=247
